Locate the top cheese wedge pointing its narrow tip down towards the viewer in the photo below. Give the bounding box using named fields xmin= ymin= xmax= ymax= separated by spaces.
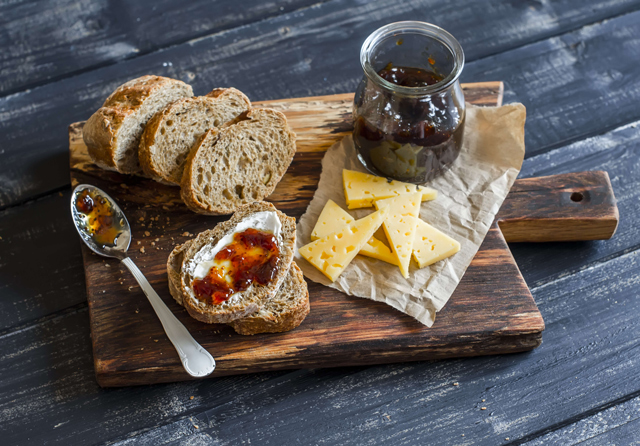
xmin=374 ymin=192 xmax=422 ymax=279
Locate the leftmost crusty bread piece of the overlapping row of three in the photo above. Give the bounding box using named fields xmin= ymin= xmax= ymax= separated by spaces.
xmin=82 ymin=76 xmax=193 ymax=173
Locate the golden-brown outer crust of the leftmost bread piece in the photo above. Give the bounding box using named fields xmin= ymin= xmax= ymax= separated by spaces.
xmin=83 ymin=75 xmax=193 ymax=174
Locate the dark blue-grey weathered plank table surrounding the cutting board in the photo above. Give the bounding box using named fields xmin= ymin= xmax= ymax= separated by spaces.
xmin=0 ymin=0 xmax=640 ymax=445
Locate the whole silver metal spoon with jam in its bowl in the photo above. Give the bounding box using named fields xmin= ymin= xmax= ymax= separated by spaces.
xmin=71 ymin=184 xmax=216 ymax=378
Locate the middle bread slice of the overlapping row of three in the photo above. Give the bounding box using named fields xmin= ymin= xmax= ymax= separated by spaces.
xmin=138 ymin=88 xmax=251 ymax=185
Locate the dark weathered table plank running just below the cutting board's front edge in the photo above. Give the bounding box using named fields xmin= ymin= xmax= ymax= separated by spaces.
xmin=63 ymin=251 xmax=640 ymax=446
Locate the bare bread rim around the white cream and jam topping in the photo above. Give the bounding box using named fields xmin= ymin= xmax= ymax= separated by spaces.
xmin=178 ymin=202 xmax=296 ymax=324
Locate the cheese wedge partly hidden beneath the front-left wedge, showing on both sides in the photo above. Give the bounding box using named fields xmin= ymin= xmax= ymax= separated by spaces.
xmin=311 ymin=200 xmax=398 ymax=265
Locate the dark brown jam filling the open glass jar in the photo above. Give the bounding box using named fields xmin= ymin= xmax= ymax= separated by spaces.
xmin=353 ymin=61 xmax=464 ymax=183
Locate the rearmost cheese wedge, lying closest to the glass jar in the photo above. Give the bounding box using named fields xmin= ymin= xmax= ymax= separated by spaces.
xmin=342 ymin=169 xmax=438 ymax=209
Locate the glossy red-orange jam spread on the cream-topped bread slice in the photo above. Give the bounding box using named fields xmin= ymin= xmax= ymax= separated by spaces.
xmin=191 ymin=228 xmax=280 ymax=305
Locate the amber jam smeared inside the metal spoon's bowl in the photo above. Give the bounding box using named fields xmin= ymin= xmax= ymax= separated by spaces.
xmin=75 ymin=189 xmax=124 ymax=246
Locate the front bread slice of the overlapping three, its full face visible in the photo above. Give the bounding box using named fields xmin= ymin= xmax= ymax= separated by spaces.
xmin=180 ymin=108 xmax=296 ymax=215
